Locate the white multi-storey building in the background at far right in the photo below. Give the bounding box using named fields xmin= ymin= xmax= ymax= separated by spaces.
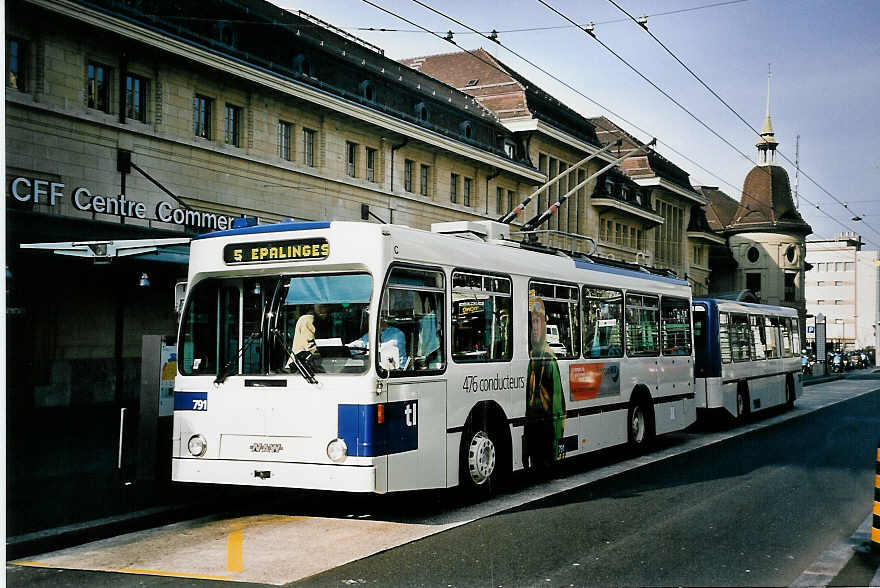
xmin=805 ymin=232 xmax=880 ymax=350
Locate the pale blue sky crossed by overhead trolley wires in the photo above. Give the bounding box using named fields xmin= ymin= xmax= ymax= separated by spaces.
xmin=271 ymin=0 xmax=880 ymax=249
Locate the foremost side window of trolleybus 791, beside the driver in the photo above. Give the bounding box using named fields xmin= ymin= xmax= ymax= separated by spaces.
xmin=376 ymin=266 xmax=446 ymax=376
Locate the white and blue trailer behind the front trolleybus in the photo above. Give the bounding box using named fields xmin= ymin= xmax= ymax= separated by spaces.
xmin=693 ymin=298 xmax=802 ymax=420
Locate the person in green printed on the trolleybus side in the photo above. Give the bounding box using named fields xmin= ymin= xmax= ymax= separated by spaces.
xmin=523 ymin=295 xmax=565 ymax=468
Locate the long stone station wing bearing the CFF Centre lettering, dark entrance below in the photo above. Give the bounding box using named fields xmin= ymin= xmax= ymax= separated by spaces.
xmin=5 ymin=0 xmax=545 ymax=536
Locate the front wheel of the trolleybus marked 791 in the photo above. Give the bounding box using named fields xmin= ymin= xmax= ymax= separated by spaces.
xmin=458 ymin=421 xmax=510 ymax=500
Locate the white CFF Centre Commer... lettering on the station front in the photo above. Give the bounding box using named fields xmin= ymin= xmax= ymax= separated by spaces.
xmin=9 ymin=177 xmax=234 ymax=230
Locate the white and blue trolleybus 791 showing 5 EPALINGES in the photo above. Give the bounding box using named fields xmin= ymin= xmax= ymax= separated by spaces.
xmin=172 ymin=221 xmax=696 ymax=493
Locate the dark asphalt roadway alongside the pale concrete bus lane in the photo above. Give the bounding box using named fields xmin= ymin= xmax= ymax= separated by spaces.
xmin=6 ymin=381 xmax=880 ymax=587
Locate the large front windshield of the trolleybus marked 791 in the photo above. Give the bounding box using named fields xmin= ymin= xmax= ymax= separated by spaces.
xmin=179 ymin=273 xmax=373 ymax=378
